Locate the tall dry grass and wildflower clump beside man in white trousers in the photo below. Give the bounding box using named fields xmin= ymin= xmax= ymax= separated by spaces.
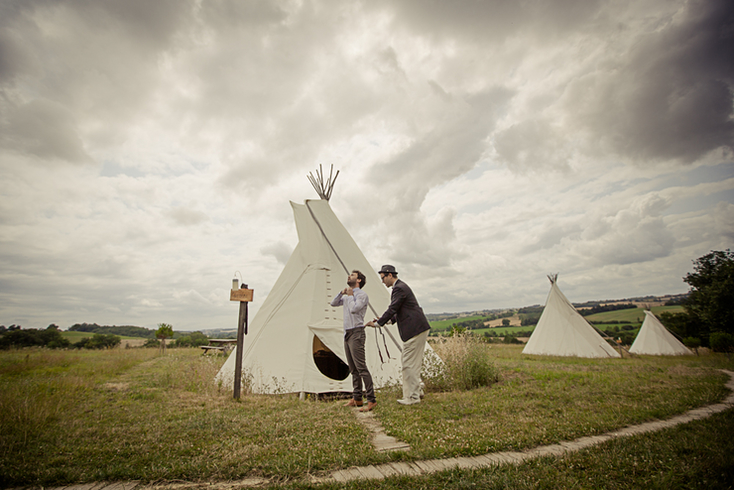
xmin=421 ymin=333 xmax=499 ymax=391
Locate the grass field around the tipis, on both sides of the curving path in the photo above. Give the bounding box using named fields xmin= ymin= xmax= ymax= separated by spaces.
xmin=0 ymin=344 xmax=734 ymax=488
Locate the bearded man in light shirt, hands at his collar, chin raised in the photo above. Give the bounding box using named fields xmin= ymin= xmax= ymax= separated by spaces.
xmin=331 ymin=271 xmax=377 ymax=412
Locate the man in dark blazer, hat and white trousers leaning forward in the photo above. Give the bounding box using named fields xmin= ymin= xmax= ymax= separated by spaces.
xmin=366 ymin=265 xmax=431 ymax=405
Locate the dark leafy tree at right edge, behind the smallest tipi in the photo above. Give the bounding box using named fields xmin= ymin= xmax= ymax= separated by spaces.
xmin=683 ymin=249 xmax=734 ymax=335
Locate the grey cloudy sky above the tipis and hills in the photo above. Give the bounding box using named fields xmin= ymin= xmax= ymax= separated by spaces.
xmin=0 ymin=0 xmax=734 ymax=330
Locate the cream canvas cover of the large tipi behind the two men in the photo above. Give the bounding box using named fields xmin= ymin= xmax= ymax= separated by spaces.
xmin=216 ymin=199 xmax=402 ymax=394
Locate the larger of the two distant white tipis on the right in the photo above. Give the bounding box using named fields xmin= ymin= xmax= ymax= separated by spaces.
xmin=522 ymin=274 xmax=620 ymax=357
